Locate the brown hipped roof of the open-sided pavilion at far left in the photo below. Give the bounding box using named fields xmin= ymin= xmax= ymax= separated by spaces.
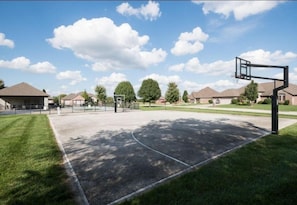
xmin=0 ymin=82 xmax=49 ymax=97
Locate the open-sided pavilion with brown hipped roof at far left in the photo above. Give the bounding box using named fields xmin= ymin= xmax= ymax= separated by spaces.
xmin=0 ymin=82 xmax=49 ymax=109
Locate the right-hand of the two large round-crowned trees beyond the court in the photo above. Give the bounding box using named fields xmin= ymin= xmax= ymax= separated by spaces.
xmin=138 ymin=78 xmax=161 ymax=106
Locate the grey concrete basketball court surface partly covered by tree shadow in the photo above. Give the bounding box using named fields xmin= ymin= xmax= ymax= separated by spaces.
xmin=49 ymin=111 xmax=296 ymax=205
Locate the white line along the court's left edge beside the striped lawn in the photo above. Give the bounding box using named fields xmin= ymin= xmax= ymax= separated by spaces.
xmin=49 ymin=119 xmax=89 ymax=205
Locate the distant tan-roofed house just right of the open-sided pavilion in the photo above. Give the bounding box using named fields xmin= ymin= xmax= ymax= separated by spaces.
xmin=61 ymin=92 xmax=97 ymax=106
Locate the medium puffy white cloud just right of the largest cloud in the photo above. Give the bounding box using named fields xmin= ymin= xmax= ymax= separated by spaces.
xmin=171 ymin=27 xmax=208 ymax=56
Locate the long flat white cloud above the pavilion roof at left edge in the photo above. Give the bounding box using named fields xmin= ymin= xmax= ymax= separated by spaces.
xmin=0 ymin=56 xmax=56 ymax=73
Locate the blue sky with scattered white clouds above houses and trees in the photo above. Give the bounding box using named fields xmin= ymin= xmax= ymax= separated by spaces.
xmin=0 ymin=0 xmax=297 ymax=96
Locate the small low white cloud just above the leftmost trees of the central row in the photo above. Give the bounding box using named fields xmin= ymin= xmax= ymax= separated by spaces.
xmin=96 ymin=72 xmax=127 ymax=96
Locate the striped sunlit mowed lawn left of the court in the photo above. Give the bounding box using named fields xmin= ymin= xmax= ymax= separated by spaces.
xmin=0 ymin=115 xmax=76 ymax=205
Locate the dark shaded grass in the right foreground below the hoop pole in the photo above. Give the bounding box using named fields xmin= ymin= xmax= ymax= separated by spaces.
xmin=123 ymin=124 xmax=297 ymax=205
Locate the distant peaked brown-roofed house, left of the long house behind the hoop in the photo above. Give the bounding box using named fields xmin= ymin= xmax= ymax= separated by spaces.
xmin=189 ymin=87 xmax=218 ymax=103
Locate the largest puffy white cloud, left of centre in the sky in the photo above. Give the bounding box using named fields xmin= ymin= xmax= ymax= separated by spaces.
xmin=47 ymin=18 xmax=167 ymax=71
